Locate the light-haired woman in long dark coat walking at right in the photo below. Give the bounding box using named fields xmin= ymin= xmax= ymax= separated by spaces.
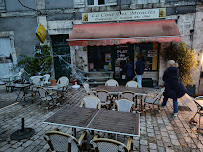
xmin=162 ymin=60 xmax=187 ymax=117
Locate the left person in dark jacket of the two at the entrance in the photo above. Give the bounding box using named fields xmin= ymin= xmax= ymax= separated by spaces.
xmin=124 ymin=57 xmax=135 ymax=81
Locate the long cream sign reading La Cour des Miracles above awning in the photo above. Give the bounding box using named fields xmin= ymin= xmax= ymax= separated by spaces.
xmin=82 ymin=8 xmax=166 ymax=22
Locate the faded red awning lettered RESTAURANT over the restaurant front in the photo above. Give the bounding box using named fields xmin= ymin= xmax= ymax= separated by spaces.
xmin=68 ymin=20 xmax=181 ymax=46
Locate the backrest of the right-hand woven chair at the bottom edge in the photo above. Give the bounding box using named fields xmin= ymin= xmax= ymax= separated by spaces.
xmin=90 ymin=138 xmax=128 ymax=152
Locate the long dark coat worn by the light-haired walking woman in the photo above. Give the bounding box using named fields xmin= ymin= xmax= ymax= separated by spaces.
xmin=163 ymin=67 xmax=187 ymax=99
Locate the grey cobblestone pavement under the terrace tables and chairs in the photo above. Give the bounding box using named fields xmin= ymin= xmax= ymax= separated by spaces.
xmin=0 ymin=86 xmax=203 ymax=152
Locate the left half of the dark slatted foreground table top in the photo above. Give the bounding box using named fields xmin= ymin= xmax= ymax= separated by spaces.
xmin=44 ymin=105 xmax=98 ymax=129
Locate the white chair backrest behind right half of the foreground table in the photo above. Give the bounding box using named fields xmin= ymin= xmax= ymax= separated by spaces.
xmin=116 ymin=98 xmax=133 ymax=112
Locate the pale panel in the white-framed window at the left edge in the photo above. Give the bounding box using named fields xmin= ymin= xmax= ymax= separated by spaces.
xmin=0 ymin=38 xmax=12 ymax=57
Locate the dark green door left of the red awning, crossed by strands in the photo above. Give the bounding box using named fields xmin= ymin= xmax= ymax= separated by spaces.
xmin=51 ymin=35 xmax=71 ymax=79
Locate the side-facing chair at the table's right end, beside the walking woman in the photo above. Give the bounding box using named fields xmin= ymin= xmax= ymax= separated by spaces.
xmin=144 ymin=87 xmax=165 ymax=112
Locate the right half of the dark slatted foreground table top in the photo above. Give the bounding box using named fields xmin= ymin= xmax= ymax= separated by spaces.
xmin=87 ymin=109 xmax=140 ymax=136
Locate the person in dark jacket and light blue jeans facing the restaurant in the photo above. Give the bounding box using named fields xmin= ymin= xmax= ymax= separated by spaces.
xmin=135 ymin=54 xmax=145 ymax=88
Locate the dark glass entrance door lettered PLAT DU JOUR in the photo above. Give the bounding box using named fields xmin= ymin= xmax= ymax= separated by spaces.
xmin=113 ymin=44 xmax=134 ymax=85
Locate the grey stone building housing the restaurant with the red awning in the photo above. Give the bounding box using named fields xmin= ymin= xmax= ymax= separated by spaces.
xmin=0 ymin=0 xmax=203 ymax=93
